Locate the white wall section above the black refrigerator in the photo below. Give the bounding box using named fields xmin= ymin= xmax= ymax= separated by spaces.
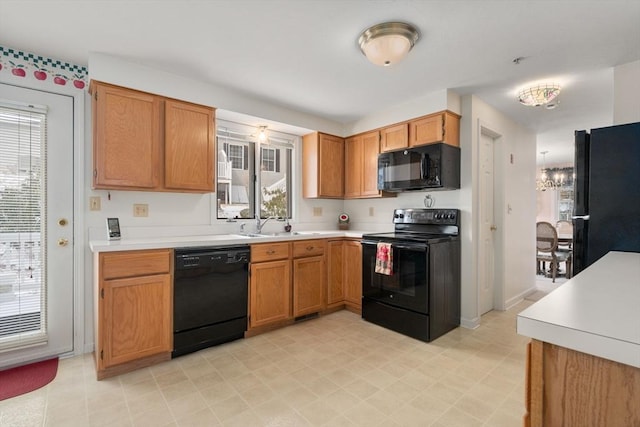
xmin=613 ymin=61 xmax=640 ymax=125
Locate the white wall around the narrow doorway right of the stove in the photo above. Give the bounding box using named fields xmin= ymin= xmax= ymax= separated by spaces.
xmin=460 ymin=95 xmax=536 ymax=327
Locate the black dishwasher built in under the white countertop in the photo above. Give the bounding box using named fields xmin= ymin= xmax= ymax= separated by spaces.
xmin=171 ymin=245 xmax=250 ymax=357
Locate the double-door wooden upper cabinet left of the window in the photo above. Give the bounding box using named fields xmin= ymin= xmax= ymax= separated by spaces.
xmin=90 ymin=81 xmax=215 ymax=193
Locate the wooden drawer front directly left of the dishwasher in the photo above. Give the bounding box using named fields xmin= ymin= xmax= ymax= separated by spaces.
xmin=100 ymin=249 xmax=172 ymax=280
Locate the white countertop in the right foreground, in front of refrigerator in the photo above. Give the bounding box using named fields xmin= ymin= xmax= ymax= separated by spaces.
xmin=517 ymin=252 xmax=640 ymax=368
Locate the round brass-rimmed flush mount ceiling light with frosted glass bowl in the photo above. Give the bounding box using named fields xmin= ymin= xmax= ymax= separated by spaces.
xmin=358 ymin=22 xmax=420 ymax=67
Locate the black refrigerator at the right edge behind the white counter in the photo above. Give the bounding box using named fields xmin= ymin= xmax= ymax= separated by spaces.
xmin=573 ymin=122 xmax=640 ymax=275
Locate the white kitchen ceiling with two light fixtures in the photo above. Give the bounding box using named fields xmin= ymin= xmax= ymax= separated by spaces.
xmin=0 ymin=0 xmax=640 ymax=164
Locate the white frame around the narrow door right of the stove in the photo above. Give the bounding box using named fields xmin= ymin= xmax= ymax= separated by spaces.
xmin=473 ymin=119 xmax=505 ymax=318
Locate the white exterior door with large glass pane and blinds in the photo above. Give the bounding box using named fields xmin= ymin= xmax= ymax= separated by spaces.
xmin=0 ymin=84 xmax=74 ymax=368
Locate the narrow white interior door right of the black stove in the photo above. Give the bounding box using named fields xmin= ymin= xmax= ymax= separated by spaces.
xmin=478 ymin=133 xmax=496 ymax=315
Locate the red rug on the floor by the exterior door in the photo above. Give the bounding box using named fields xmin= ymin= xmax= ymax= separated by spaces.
xmin=0 ymin=357 xmax=58 ymax=400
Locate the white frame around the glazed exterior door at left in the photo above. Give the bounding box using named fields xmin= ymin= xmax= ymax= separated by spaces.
xmin=0 ymin=78 xmax=87 ymax=357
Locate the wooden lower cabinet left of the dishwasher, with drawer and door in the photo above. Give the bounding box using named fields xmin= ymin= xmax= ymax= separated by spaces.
xmin=95 ymin=249 xmax=173 ymax=379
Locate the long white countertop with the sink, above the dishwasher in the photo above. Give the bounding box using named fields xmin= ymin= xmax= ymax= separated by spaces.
xmin=89 ymin=230 xmax=363 ymax=253
